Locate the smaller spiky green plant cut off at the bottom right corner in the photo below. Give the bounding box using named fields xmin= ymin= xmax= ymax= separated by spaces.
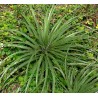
xmin=58 ymin=63 xmax=98 ymax=93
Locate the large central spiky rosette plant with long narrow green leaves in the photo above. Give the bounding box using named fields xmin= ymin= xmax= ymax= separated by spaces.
xmin=0 ymin=5 xmax=87 ymax=92
